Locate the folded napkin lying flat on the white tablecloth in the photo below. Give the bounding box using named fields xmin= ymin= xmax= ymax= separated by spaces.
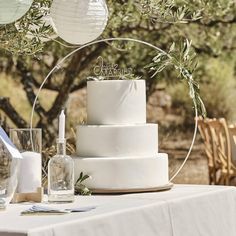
xmin=21 ymin=206 xmax=96 ymax=215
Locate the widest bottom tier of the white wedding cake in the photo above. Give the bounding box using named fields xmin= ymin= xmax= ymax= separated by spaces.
xmin=74 ymin=153 xmax=169 ymax=191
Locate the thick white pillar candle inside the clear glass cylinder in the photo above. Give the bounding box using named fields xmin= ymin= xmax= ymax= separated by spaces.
xmin=18 ymin=151 xmax=42 ymax=193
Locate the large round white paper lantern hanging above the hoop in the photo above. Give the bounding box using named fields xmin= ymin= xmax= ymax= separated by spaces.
xmin=50 ymin=0 xmax=108 ymax=44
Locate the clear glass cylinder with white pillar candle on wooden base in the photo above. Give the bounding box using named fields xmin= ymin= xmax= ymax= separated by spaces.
xmin=10 ymin=129 xmax=43 ymax=202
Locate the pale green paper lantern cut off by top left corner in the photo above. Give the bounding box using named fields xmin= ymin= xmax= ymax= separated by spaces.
xmin=0 ymin=0 xmax=33 ymax=24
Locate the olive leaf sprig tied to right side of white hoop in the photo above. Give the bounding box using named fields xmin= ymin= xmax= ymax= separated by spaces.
xmin=145 ymin=39 xmax=206 ymax=116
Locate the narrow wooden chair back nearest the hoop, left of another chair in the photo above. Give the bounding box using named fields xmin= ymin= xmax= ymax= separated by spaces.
xmin=198 ymin=117 xmax=218 ymax=184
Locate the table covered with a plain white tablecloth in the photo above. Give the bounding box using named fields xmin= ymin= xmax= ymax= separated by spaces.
xmin=0 ymin=185 xmax=236 ymax=236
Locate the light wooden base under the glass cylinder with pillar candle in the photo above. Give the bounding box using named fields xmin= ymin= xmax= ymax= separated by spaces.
xmin=11 ymin=187 xmax=43 ymax=203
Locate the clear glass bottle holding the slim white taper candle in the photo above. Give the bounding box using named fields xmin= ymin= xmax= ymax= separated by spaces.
xmin=48 ymin=140 xmax=74 ymax=202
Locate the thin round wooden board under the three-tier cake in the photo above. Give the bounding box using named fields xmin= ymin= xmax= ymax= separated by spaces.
xmin=91 ymin=183 xmax=174 ymax=194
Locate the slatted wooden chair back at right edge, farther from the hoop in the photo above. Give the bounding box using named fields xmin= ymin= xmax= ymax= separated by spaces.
xmin=206 ymin=118 xmax=236 ymax=185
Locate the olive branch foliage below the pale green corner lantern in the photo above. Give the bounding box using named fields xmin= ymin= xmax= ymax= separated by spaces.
xmin=0 ymin=0 xmax=54 ymax=56
